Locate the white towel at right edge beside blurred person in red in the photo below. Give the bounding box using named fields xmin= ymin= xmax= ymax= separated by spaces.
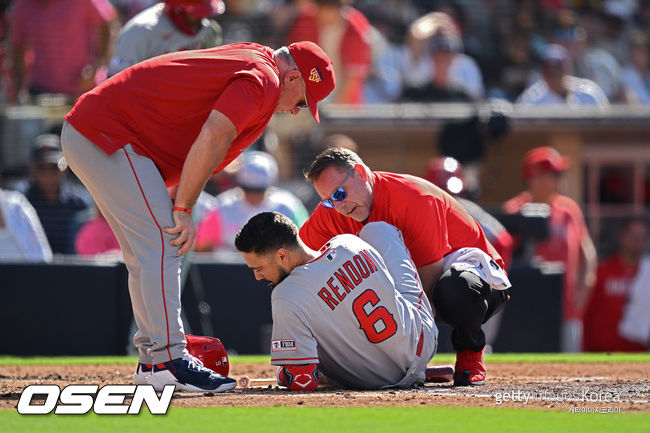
xmin=618 ymin=256 xmax=650 ymax=345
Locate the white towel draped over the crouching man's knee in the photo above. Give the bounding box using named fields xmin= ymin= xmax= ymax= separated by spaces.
xmin=442 ymin=248 xmax=512 ymax=290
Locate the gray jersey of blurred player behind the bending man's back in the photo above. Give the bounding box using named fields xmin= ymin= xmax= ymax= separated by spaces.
xmin=108 ymin=3 xmax=222 ymax=77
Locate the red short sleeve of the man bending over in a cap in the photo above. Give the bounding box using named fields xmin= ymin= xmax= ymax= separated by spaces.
xmin=212 ymin=78 xmax=265 ymax=134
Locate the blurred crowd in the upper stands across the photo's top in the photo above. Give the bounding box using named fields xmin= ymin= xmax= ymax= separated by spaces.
xmin=0 ymin=0 xmax=650 ymax=106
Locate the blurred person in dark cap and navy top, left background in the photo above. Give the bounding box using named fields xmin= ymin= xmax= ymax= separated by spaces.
xmin=17 ymin=134 xmax=91 ymax=254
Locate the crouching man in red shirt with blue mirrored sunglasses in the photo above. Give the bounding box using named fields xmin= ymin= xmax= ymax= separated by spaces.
xmin=300 ymin=148 xmax=510 ymax=385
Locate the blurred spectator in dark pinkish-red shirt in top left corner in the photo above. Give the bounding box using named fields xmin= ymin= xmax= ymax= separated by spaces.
xmin=10 ymin=0 xmax=120 ymax=101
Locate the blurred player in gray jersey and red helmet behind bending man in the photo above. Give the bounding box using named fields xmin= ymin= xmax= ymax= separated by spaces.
xmin=108 ymin=0 xmax=225 ymax=77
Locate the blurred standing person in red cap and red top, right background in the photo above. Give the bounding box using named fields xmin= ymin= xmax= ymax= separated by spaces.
xmin=503 ymin=146 xmax=597 ymax=352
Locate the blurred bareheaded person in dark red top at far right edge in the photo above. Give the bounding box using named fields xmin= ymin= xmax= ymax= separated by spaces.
xmin=583 ymin=218 xmax=648 ymax=352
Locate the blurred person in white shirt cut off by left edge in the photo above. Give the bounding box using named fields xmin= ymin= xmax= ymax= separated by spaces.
xmin=0 ymin=189 xmax=52 ymax=262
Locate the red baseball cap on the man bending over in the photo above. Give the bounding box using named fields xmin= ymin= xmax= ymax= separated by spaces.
xmin=289 ymin=41 xmax=336 ymax=123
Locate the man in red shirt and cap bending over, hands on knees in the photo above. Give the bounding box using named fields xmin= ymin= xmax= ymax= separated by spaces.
xmin=62 ymin=42 xmax=334 ymax=392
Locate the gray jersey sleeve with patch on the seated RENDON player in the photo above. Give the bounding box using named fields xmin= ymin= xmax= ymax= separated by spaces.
xmin=271 ymin=298 xmax=318 ymax=365
